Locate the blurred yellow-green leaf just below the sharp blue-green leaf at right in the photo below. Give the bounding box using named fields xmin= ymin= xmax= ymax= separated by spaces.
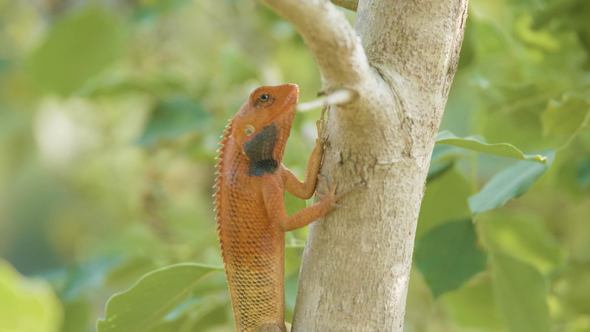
xmin=479 ymin=213 xmax=564 ymax=274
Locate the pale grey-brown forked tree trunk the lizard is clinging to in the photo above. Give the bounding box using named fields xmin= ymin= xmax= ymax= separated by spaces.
xmin=263 ymin=0 xmax=467 ymax=332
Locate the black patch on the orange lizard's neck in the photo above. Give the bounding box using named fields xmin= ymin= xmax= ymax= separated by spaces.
xmin=244 ymin=124 xmax=279 ymax=176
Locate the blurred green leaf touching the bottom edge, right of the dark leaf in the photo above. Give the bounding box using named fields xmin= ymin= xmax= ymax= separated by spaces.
xmin=492 ymin=254 xmax=550 ymax=332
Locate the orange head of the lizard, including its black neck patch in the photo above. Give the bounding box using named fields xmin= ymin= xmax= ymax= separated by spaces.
xmin=232 ymin=84 xmax=299 ymax=175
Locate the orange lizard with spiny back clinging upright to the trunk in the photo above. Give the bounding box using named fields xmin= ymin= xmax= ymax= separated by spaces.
xmin=214 ymin=84 xmax=338 ymax=332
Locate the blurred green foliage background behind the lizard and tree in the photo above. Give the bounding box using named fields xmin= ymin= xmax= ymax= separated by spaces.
xmin=0 ymin=0 xmax=590 ymax=332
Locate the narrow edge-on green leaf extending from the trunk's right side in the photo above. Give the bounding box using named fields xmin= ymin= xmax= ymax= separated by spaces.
xmin=436 ymin=130 xmax=547 ymax=163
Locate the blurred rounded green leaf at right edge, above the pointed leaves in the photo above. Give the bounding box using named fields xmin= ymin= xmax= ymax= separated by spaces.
xmin=541 ymin=94 xmax=590 ymax=137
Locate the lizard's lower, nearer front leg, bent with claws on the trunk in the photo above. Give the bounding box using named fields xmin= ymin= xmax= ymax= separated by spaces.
xmin=262 ymin=179 xmax=337 ymax=232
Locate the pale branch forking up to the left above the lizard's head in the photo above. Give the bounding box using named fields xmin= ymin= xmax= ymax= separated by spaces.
xmin=262 ymin=0 xmax=371 ymax=88
